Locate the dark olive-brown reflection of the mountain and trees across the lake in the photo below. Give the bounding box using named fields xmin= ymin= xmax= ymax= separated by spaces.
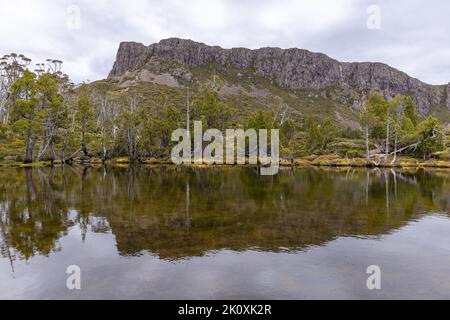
xmin=0 ymin=166 xmax=450 ymax=260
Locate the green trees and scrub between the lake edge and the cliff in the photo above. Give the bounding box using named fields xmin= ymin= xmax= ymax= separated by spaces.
xmin=0 ymin=54 xmax=450 ymax=166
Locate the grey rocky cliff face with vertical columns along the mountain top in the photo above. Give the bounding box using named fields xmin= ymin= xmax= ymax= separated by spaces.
xmin=109 ymin=38 xmax=450 ymax=113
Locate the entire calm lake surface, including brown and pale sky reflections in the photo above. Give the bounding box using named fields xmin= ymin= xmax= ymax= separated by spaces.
xmin=0 ymin=166 xmax=450 ymax=299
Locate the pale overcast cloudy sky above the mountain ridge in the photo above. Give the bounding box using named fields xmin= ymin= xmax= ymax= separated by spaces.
xmin=0 ymin=0 xmax=450 ymax=84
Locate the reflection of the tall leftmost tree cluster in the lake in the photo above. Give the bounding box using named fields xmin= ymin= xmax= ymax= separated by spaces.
xmin=0 ymin=169 xmax=70 ymax=261
